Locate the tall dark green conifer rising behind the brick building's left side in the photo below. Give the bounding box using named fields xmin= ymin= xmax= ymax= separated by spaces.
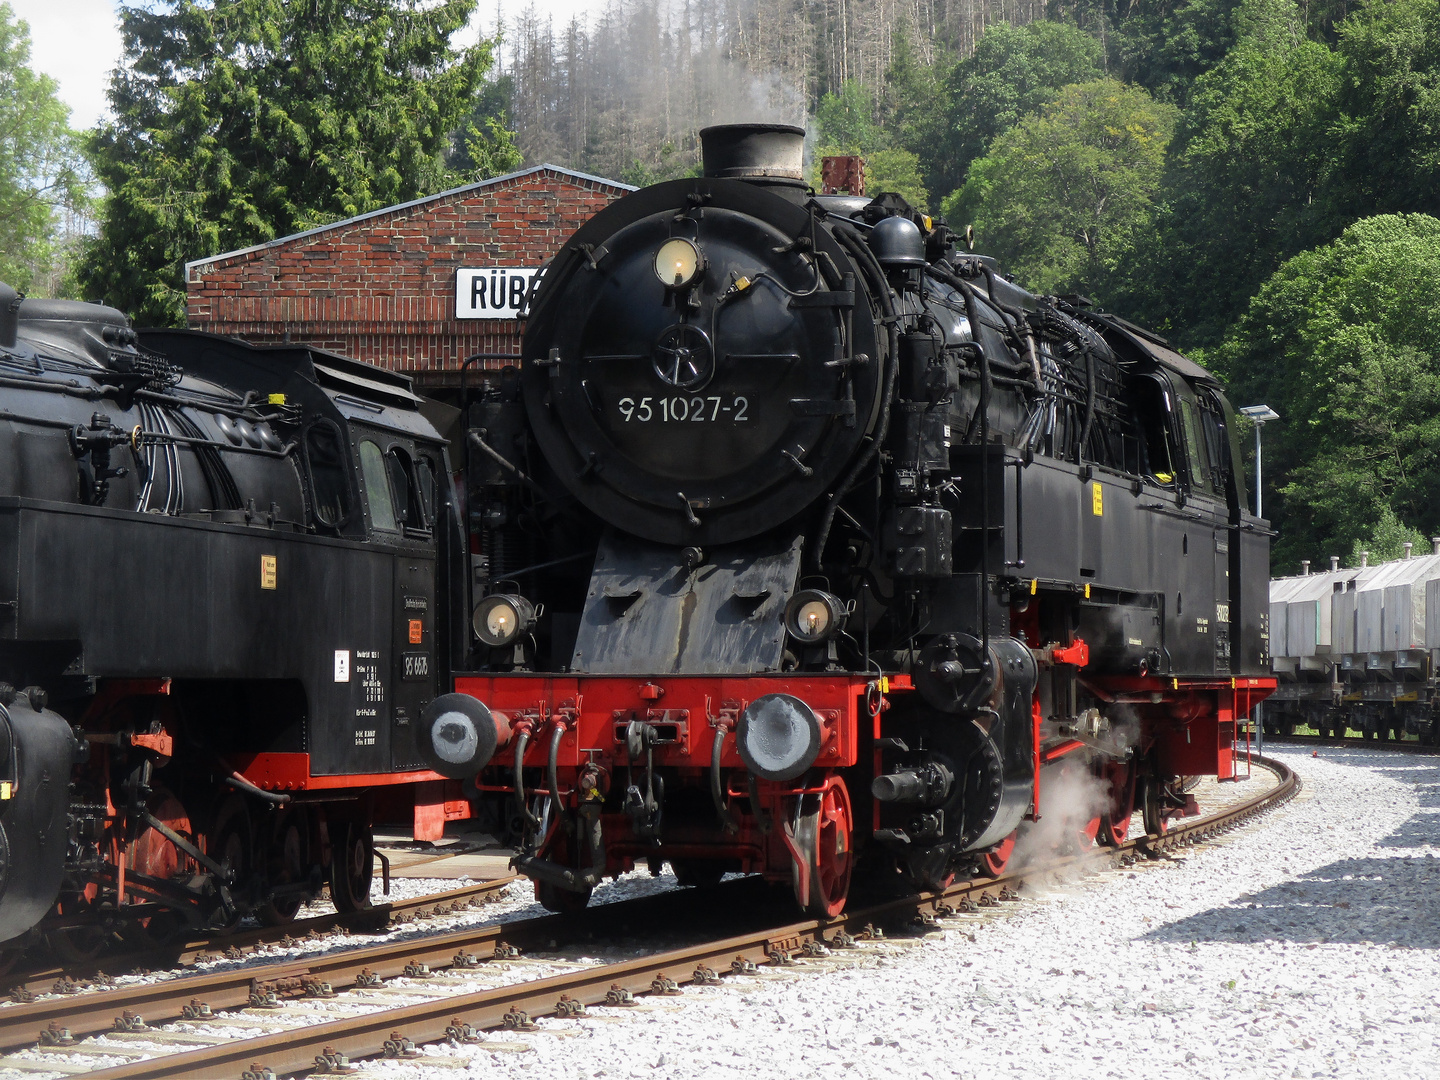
xmin=81 ymin=0 xmax=506 ymax=324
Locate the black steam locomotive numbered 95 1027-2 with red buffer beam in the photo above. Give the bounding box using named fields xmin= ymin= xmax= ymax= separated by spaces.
xmin=446 ymin=125 xmax=1274 ymax=914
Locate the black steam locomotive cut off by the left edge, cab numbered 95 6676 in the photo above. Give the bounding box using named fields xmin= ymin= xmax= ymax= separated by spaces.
xmin=0 ymin=287 xmax=469 ymax=956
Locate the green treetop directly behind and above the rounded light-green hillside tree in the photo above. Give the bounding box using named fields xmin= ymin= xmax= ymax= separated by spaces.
xmin=912 ymin=22 xmax=1103 ymax=201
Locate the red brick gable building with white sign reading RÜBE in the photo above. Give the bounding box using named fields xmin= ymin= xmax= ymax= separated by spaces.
xmin=186 ymin=166 xmax=634 ymax=390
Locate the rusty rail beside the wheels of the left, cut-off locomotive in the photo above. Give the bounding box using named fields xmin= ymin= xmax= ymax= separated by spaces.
xmin=0 ymin=874 xmax=517 ymax=1015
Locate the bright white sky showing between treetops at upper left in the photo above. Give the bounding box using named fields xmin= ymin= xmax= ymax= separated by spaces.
xmin=7 ymin=0 xmax=602 ymax=128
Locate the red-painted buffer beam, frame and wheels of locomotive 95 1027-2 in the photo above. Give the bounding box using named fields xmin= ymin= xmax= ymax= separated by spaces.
xmin=455 ymin=659 xmax=1274 ymax=916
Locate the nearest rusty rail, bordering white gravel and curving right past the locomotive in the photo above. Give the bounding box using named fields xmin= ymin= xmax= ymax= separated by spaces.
xmin=53 ymin=757 xmax=1300 ymax=1080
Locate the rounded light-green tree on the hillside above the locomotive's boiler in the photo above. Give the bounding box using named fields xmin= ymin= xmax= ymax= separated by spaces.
xmin=943 ymin=79 xmax=1176 ymax=300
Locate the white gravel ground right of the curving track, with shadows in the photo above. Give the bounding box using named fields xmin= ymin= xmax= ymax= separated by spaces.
xmin=366 ymin=747 xmax=1440 ymax=1080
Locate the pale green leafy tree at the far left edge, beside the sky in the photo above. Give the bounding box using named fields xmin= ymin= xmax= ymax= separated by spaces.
xmin=0 ymin=3 xmax=86 ymax=294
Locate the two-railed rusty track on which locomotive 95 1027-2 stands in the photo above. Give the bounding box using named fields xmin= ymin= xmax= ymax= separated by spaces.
xmin=0 ymin=757 xmax=1299 ymax=1080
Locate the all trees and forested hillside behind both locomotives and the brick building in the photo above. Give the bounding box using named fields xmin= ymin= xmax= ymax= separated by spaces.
xmin=0 ymin=0 xmax=1440 ymax=570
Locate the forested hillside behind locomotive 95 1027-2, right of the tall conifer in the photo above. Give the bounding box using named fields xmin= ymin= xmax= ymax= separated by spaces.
xmin=490 ymin=0 xmax=1440 ymax=572
